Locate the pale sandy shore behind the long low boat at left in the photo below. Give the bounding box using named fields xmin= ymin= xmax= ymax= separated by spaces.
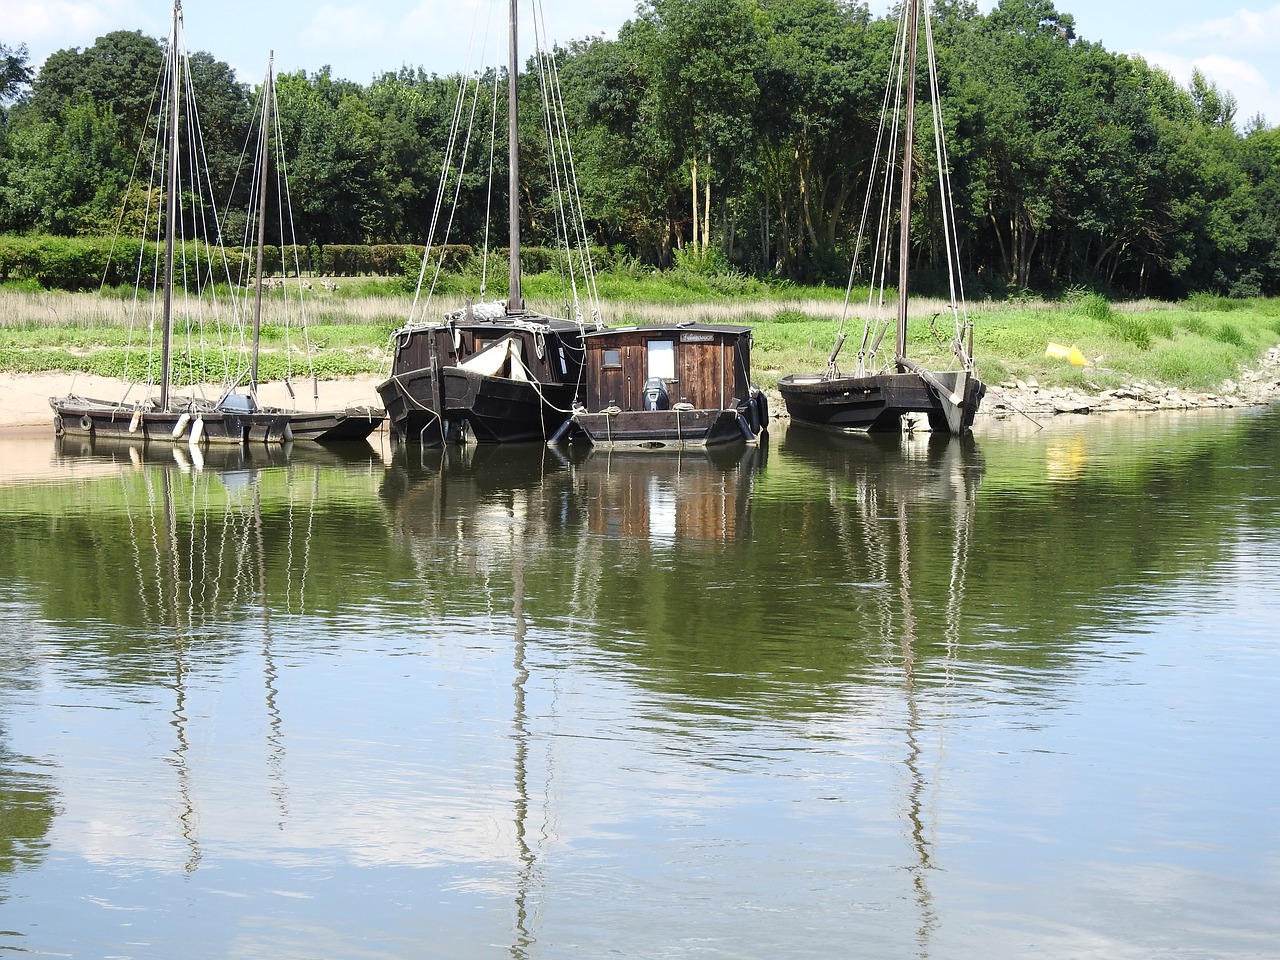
xmin=0 ymin=372 xmax=381 ymax=435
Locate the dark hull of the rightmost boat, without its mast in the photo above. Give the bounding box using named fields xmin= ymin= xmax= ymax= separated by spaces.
xmin=778 ymin=371 xmax=987 ymax=434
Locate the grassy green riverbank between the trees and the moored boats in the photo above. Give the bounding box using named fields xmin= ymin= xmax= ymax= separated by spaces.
xmin=0 ymin=280 xmax=1280 ymax=390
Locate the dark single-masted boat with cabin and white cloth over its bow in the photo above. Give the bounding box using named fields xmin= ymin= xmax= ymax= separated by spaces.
xmin=378 ymin=0 xmax=599 ymax=444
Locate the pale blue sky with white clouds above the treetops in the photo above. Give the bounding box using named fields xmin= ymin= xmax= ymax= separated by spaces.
xmin=0 ymin=0 xmax=1280 ymax=125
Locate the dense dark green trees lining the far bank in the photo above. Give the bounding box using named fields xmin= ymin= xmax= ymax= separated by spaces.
xmin=0 ymin=0 xmax=1280 ymax=300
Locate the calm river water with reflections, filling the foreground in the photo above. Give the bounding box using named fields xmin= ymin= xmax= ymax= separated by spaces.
xmin=0 ymin=411 xmax=1280 ymax=960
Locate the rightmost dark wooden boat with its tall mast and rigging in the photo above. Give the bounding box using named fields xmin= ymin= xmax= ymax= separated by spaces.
xmin=778 ymin=0 xmax=987 ymax=435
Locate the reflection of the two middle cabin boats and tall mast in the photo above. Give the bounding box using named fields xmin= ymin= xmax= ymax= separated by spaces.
xmin=380 ymin=435 xmax=767 ymax=956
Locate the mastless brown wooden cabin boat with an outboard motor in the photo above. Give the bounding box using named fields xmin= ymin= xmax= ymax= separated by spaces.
xmin=552 ymin=323 xmax=769 ymax=449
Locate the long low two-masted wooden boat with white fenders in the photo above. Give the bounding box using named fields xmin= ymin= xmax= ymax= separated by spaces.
xmin=49 ymin=0 xmax=385 ymax=444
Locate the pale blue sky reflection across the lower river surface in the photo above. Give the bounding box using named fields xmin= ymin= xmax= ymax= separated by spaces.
xmin=9 ymin=564 xmax=1280 ymax=956
